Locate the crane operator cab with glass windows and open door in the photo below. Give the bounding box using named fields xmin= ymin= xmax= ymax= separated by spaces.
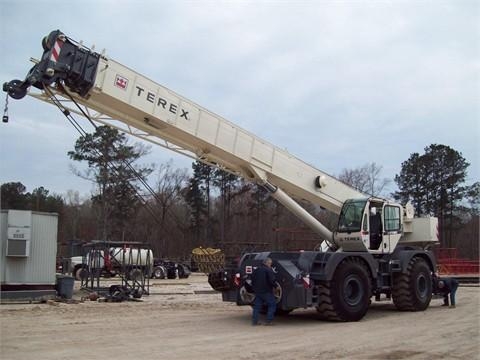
xmin=334 ymin=198 xmax=403 ymax=254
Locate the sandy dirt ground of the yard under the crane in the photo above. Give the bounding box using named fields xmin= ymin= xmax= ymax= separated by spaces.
xmin=0 ymin=274 xmax=480 ymax=360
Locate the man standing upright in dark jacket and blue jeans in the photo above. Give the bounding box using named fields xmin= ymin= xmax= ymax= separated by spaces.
xmin=252 ymin=258 xmax=278 ymax=325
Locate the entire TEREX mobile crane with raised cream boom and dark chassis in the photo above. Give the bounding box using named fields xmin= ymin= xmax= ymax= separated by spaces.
xmin=3 ymin=30 xmax=438 ymax=321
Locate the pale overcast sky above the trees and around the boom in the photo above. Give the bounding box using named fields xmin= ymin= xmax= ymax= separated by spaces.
xmin=0 ymin=0 xmax=480 ymax=200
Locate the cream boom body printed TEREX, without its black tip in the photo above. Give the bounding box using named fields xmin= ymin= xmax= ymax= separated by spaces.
xmin=89 ymin=59 xmax=364 ymax=213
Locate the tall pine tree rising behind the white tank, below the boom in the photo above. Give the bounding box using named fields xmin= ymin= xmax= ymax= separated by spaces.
xmin=68 ymin=126 xmax=152 ymax=240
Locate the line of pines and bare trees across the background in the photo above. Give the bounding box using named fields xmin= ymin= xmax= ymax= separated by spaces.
xmin=1 ymin=126 xmax=480 ymax=258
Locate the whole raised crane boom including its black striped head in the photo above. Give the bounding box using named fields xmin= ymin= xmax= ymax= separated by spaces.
xmin=4 ymin=30 xmax=365 ymax=214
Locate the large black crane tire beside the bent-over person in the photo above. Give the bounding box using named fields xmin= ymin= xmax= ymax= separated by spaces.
xmin=392 ymin=256 xmax=432 ymax=311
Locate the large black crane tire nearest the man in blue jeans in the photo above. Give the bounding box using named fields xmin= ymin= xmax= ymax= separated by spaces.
xmin=317 ymin=258 xmax=372 ymax=321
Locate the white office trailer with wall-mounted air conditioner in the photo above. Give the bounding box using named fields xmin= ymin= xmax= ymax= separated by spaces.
xmin=0 ymin=210 xmax=58 ymax=300
